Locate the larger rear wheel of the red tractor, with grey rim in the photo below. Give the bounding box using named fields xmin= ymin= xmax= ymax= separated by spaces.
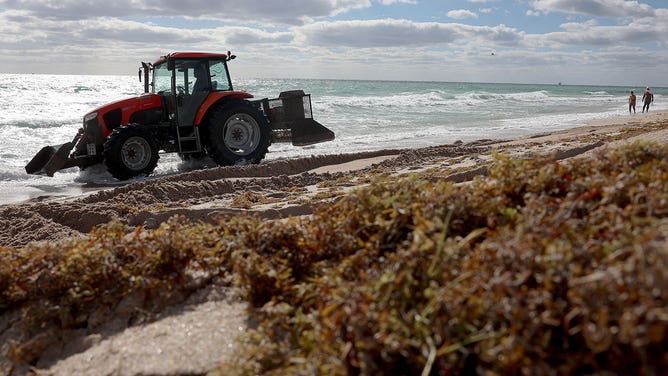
xmin=207 ymin=100 xmax=271 ymax=166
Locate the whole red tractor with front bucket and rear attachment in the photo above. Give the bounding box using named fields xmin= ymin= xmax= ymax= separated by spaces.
xmin=26 ymin=52 xmax=334 ymax=180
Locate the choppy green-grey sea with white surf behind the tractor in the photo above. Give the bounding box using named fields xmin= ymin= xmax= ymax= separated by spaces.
xmin=0 ymin=74 xmax=668 ymax=204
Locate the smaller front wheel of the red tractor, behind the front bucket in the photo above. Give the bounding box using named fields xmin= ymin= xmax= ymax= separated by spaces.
xmin=104 ymin=124 xmax=159 ymax=180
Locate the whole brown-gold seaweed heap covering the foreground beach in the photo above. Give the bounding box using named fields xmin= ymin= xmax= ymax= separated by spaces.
xmin=0 ymin=143 xmax=668 ymax=375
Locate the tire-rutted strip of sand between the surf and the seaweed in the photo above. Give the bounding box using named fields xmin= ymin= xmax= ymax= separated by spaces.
xmin=0 ymin=111 xmax=668 ymax=247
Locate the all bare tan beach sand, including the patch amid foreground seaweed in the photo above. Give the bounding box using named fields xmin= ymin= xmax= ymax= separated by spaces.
xmin=0 ymin=112 xmax=668 ymax=375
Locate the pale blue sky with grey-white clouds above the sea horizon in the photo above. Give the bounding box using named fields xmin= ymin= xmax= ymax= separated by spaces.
xmin=0 ymin=0 xmax=668 ymax=86
